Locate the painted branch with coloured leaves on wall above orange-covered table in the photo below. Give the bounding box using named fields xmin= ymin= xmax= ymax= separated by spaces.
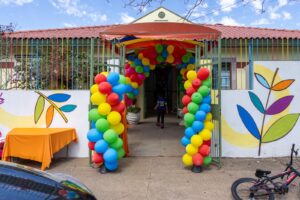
xmin=34 ymin=91 xmax=77 ymax=128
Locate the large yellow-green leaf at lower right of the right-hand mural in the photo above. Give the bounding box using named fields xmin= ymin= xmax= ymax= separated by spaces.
xmin=262 ymin=113 xmax=300 ymax=143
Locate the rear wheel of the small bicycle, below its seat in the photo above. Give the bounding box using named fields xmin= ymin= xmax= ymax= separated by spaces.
xmin=231 ymin=178 xmax=274 ymax=200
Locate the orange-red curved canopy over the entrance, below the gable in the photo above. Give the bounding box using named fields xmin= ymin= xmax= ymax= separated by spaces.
xmin=100 ymin=22 xmax=221 ymax=49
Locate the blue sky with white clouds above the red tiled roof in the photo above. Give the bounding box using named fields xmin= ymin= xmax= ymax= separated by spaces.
xmin=0 ymin=0 xmax=300 ymax=30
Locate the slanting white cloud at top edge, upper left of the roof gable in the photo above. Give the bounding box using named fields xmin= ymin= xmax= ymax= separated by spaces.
xmin=50 ymin=0 xmax=107 ymax=22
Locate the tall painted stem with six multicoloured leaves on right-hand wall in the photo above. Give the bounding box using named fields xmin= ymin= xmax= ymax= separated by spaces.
xmin=237 ymin=68 xmax=300 ymax=156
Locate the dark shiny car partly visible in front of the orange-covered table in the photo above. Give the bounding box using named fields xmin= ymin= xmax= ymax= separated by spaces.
xmin=0 ymin=161 xmax=96 ymax=200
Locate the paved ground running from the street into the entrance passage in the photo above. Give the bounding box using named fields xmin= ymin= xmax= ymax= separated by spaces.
xmin=18 ymin=115 xmax=300 ymax=200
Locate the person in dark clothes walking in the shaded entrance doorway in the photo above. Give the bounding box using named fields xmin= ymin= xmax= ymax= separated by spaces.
xmin=154 ymin=93 xmax=168 ymax=128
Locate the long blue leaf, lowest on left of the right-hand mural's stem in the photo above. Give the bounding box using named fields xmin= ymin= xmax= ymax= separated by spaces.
xmin=237 ymin=105 xmax=260 ymax=140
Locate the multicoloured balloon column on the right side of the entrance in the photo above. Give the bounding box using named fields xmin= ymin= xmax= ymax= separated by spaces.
xmin=181 ymin=67 xmax=214 ymax=171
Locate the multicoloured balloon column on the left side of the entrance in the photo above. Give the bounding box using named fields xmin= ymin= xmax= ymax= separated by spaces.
xmin=87 ymin=72 xmax=128 ymax=171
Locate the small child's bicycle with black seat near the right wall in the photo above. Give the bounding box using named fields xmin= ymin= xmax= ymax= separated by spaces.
xmin=231 ymin=144 xmax=300 ymax=200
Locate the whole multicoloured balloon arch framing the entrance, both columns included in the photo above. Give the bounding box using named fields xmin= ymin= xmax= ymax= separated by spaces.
xmin=87 ymin=43 xmax=214 ymax=171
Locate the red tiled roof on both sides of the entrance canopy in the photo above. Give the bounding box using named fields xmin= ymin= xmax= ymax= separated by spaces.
xmin=5 ymin=24 xmax=300 ymax=39
